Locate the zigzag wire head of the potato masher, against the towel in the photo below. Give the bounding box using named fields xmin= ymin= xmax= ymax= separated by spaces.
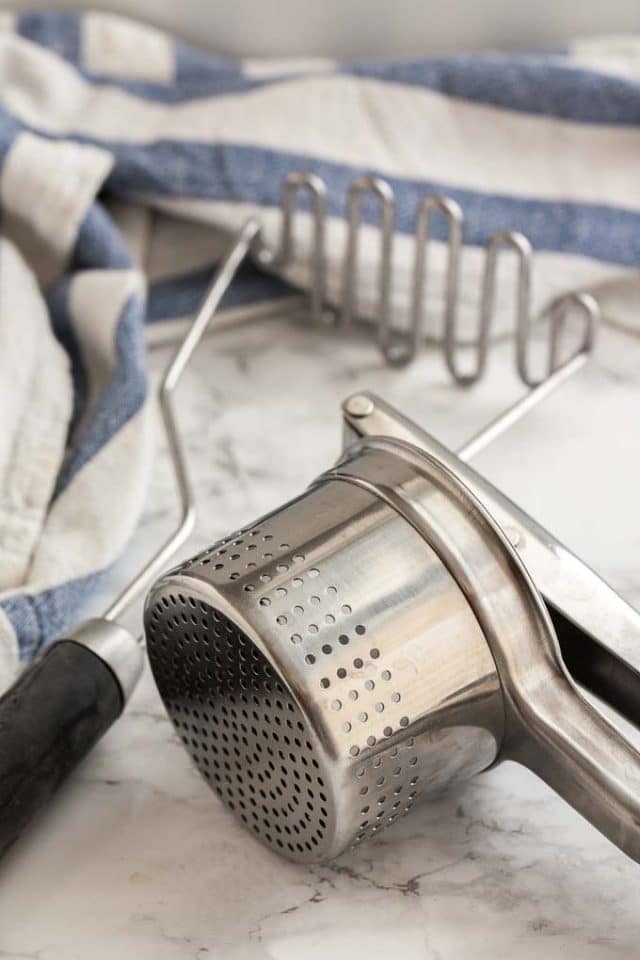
xmin=208 ymin=171 xmax=599 ymax=387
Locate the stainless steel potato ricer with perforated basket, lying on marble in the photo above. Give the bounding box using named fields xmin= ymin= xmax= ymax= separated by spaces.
xmin=145 ymin=394 xmax=640 ymax=861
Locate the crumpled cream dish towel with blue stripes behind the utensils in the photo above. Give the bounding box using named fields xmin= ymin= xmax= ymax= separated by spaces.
xmin=0 ymin=12 xmax=640 ymax=688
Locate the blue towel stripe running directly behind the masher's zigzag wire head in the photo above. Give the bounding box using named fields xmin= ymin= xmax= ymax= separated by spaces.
xmin=103 ymin=141 xmax=640 ymax=266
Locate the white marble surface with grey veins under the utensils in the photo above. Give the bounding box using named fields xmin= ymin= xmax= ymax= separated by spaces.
xmin=0 ymin=322 xmax=640 ymax=960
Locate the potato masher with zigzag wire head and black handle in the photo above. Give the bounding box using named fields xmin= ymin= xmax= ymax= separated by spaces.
xmin=0 ymin=154 xmax=598 ymax=855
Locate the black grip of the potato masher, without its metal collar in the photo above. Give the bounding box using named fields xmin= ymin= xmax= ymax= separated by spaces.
xmin=0 ymin=640 xmax=124 ymax=856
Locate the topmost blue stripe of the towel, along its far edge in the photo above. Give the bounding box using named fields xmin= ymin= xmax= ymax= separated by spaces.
xmin=11 ymin=12 xmax=640 ymax=126
